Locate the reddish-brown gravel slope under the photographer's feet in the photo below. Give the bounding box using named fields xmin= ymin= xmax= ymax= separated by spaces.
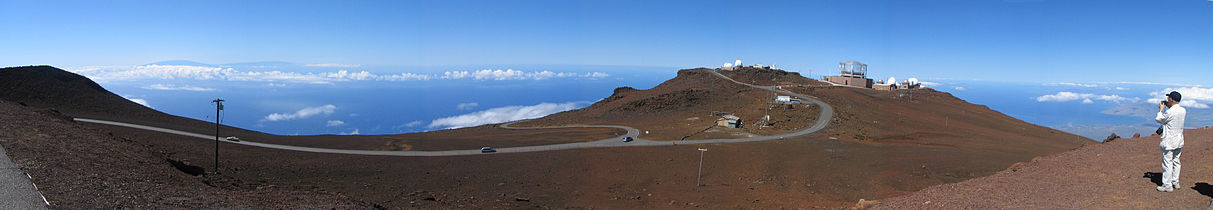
xmin=869 ymin=127 xmax=1213 ymax=209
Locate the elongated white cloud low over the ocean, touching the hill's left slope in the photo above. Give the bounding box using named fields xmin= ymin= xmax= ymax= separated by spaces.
xmin=426 ymin=102 xmax=590 ymax=129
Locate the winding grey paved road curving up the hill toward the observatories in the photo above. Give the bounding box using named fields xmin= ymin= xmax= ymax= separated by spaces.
xmin=75 ymin=72 xmax=833 ymax=157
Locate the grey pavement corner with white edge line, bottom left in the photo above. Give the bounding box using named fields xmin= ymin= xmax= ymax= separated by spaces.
xmin=0 ymin=147 xmax=46 ymax=209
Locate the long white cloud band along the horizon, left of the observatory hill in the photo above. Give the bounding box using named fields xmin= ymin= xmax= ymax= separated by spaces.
xmin=68 ymin=64 xmax=610 ymax=83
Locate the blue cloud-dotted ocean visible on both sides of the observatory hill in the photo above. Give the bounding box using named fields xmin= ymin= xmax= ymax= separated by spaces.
xmin=69 ymin=63 xmax=1213 ymax=141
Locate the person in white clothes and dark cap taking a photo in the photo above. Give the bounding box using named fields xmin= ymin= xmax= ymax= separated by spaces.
xmin=1154 ymin=91 xmax=1188 ymax=192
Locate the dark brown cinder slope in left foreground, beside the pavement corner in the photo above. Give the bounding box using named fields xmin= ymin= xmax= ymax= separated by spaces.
xmin=0 ymin=101 xmax=370 ymax=209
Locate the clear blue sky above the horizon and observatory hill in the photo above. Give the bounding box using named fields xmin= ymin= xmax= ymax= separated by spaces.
xmin=0 ymin=0 xmax=1213 ymax=84
